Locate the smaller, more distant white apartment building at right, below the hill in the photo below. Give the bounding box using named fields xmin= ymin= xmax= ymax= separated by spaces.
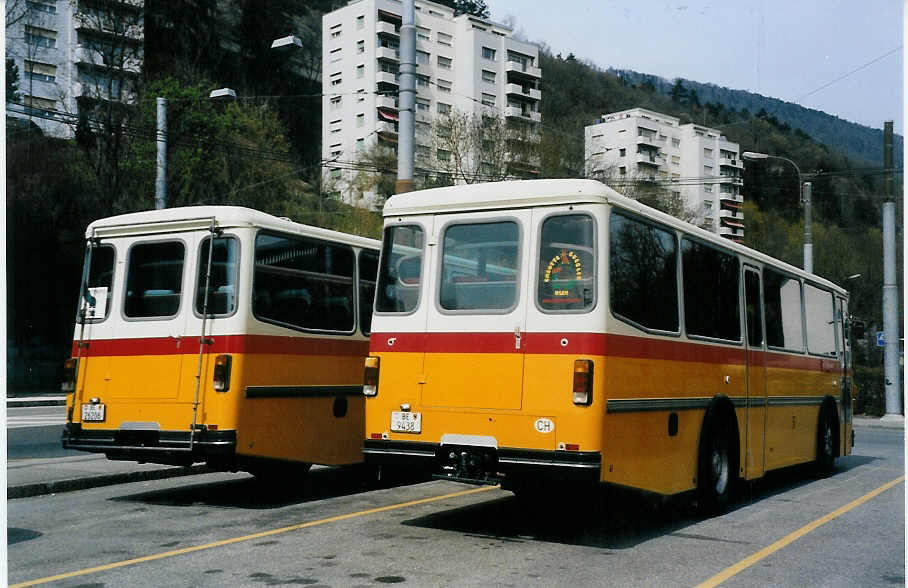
xmin=584 ymin=108 xmax=744 ymax=241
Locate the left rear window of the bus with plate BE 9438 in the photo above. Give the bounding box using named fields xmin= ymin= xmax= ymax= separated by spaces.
xmin=375 ymin=225 xmax=425 ymax=312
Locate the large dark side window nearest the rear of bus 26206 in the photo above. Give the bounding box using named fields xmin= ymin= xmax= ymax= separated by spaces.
xmin=252 ymin=233 xmax=355 ymax=332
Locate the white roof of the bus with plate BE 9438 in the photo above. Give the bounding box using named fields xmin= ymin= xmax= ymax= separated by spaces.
xmin=383 ymin=179 xmax=847 ymax=294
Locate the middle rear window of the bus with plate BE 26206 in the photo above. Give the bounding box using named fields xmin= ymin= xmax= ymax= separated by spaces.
xmin=123 ymin=241 xmax=185 ymax=318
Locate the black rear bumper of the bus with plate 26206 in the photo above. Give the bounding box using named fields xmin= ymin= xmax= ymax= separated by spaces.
xmin=62 ymin=423 xmax=236 ymax=465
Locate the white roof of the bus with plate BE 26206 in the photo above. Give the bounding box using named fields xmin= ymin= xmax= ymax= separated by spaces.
xmin=85 ymin=206 xmax=381 ymax=249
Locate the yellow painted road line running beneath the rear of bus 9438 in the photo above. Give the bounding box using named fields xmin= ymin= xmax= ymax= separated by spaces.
xmin=10 ymin=486 xmax=498 ymax=588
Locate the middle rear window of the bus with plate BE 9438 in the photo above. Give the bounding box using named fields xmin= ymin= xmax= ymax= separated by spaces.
xmin=439 ymin=221 xmax=520 ymax=310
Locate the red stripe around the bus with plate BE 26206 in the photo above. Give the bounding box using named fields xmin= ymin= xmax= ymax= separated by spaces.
xmin=72 ymin=335 xmax=369 ymax=357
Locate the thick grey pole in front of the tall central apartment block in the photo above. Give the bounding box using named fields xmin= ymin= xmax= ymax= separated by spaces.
xmin=394 ymin=0 xmax=416 ymax=194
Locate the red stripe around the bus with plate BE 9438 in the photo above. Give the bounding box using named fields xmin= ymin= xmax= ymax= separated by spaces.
xmin=369 ymin=333 xmax=840 ymax=372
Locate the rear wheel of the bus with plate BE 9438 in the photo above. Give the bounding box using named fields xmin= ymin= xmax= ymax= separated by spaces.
xmin=697 ymin=405 xmax=738 ymax=516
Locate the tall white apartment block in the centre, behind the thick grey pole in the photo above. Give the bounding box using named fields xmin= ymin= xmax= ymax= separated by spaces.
xmin=322 ymin=0 xmax=542 ymax=205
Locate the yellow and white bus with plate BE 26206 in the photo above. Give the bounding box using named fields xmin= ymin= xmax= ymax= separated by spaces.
xmin=63 ymin=206 xmax=379 ymax=474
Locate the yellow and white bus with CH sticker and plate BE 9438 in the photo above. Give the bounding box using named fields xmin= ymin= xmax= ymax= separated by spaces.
xmin=363 ymin=180 xmax=853 ymax=510
